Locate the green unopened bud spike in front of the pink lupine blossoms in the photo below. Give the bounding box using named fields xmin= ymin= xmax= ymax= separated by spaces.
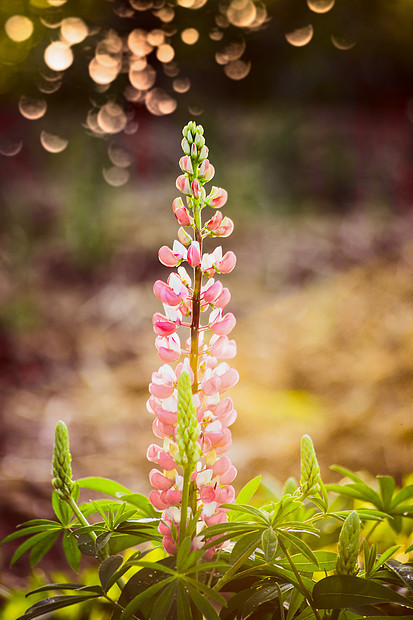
xmin=175 ymin=370 xmax=200 ymax=471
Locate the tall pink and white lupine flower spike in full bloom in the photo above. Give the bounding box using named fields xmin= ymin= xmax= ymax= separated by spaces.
xmin=147 ymin=121 xmax=239 ymax=557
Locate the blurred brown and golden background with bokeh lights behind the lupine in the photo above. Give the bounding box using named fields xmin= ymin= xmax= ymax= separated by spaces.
xmin=0 ymin=0 xmax=413 ymax=600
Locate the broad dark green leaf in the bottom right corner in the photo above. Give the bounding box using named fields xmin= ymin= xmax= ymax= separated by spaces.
xmin=313 ymin=575 xmax=413 ymax=609
